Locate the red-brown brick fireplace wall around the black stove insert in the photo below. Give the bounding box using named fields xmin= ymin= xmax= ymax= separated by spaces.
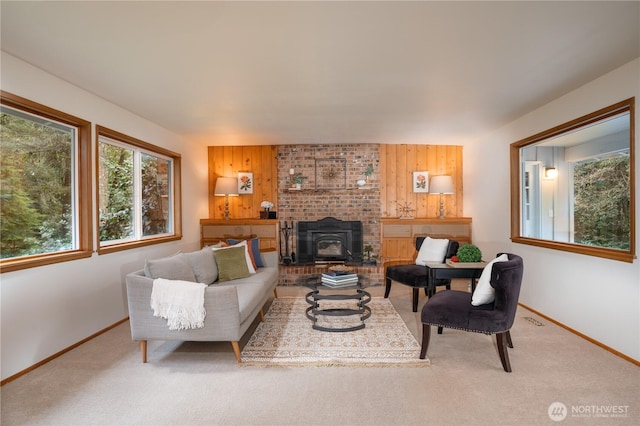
xmin=278 ymin=144 xmax=382 ymax=285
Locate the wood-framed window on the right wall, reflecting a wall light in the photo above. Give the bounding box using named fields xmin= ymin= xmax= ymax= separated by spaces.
xmin=511 ymin=98 xmax=635 ymax=262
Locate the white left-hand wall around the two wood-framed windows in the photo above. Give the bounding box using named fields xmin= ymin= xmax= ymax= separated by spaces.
xmin=0 ymin=52 xmax=208 ymax=379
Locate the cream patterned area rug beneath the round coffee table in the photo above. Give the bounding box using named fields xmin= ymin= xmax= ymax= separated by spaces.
xmin=241 ymin=297 xmax=430 ymax=367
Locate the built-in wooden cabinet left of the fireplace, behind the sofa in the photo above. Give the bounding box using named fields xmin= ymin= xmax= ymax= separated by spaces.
xmin=200 ymin=219 xmax=280 ymax=251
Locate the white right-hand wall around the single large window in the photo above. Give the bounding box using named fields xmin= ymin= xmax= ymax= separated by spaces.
xmin=464 ymin=59 xmax=640 ymax=360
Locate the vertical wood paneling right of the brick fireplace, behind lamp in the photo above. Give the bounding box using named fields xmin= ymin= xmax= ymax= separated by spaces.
xmin=380 ymin=145 xmax=463 ymax=218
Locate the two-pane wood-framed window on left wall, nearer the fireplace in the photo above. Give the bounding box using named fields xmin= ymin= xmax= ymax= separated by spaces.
xmin=96 ymin=126 xmax=181 ymax=253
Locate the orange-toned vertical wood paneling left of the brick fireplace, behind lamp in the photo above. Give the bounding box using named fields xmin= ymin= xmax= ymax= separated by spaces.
xmin=208 ymin=145 xmax=278 ymax=219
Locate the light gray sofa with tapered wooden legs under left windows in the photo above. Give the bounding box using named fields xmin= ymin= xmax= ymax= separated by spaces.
xmin=126 ymin=247 xmax=278 ymax=362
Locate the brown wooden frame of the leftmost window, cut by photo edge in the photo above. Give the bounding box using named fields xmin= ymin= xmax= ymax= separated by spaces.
xmin=0 ymin=90 xmax=93 ymax=273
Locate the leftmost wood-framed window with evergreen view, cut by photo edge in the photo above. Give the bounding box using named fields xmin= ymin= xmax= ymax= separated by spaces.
xmin=0 ymin=91 xmax=92 ymax=272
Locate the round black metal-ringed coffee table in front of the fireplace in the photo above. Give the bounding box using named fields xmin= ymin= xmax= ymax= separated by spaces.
xmin=304 ymin=276 xmax=371 ymax=332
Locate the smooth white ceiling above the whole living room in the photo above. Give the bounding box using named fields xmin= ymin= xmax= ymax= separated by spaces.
xmin=0 ymin=0 xmax=640 ymax=145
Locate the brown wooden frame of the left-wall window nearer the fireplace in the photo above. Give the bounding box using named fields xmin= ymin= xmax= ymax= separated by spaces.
xmin=94 ymin=124 xmax=182 ymax=255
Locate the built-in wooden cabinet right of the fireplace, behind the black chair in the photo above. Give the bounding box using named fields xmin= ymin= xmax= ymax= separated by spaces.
xmin=380 ymin=217 xmax=471 ymax=261
